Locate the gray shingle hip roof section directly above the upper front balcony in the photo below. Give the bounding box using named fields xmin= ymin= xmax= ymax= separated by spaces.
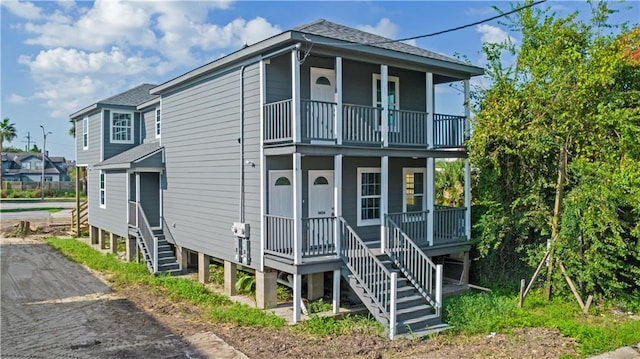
xmin=292 ymin=19 xmax=470 ymax=65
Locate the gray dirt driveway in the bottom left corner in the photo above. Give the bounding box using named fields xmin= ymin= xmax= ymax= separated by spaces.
xmin=0 ymin=238 xmax=246 ymax=358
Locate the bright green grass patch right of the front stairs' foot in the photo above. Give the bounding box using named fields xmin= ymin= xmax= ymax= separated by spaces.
xmin=444 ymin=291 xmax=640 ymax=355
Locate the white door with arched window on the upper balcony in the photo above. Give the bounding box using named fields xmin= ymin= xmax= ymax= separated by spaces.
xmin=303 ymin=67 xmax=336 ymax=140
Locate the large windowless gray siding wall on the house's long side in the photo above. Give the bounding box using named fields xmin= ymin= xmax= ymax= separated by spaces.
xmin=162 ymin=64 xmax=261 ymax=268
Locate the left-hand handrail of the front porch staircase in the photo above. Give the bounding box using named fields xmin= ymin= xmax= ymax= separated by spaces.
xmin=338 ymin=217 xmax=398 ymax=339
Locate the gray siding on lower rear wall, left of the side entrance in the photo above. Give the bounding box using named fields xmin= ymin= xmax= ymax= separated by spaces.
xmin=87 ymin=168 xmax=128 ymax=237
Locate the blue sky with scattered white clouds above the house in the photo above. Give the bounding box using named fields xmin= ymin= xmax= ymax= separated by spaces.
xmin=0 ymin=0 xmax=640 ymax=160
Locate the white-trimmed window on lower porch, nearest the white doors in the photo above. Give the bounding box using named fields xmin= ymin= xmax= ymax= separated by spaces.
xmin=358 ymin=167 xmax=382 ymax=226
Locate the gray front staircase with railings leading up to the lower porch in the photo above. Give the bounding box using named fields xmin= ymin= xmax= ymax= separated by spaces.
xmin=340 ymin=218 xmax=451 ymax=339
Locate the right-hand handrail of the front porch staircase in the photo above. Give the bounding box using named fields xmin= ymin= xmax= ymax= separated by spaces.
xmin=384 ymin=215 xmax=442 ymax=316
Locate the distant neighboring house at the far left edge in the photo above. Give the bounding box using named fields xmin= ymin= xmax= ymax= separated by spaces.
xmin=2 ymin=152 xmax=70 ymax=183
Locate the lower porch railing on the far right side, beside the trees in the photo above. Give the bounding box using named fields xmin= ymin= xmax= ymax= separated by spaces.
xmin=433 ymin=206 xmax=467 ymax=245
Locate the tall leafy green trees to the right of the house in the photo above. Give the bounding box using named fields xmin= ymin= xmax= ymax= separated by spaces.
xmin=470 ymin=2 xmax=640 ymax=296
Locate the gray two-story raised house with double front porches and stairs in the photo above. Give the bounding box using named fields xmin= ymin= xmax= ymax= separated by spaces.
xmin=71 ymin=20 xmax=483 ymax=337
